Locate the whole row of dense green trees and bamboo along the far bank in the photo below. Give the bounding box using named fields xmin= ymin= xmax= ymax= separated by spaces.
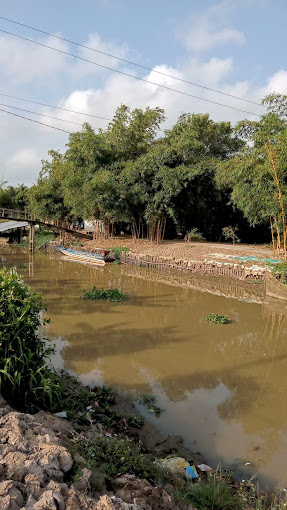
xmin=24 ymin=94 xmax=287 ymax=252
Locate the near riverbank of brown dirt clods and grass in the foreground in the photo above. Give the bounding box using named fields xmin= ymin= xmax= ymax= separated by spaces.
xmin=0 ymin=376 xmax=286 ymax=510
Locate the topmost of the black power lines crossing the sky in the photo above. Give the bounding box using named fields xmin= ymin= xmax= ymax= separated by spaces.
xmin=0 ymin=16 xmax=266 ymax=108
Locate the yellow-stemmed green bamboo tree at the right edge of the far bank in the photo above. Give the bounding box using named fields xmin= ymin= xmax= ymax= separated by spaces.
xmin=217 ymin=94 xmax=287 ymax=256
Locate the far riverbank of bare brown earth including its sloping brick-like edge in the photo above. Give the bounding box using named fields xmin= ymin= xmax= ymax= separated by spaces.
xmin=83 ymin=238 xmax=278 ymax=280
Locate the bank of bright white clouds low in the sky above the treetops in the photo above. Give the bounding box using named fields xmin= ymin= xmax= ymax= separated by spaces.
xmin=0 ymin=23 xmax=287 ymax=184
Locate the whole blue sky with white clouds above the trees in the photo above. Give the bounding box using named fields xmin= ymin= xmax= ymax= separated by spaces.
xmin=0 ymin=0 xmax=287 ymax=185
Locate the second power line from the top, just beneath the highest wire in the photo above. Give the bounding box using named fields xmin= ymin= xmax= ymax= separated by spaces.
xmin=0 ymin=29 xmax=261 ymax=117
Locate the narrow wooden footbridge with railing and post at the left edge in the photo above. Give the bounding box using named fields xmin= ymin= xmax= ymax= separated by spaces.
xmin=0 ymin=207 xmax=93 ymax=252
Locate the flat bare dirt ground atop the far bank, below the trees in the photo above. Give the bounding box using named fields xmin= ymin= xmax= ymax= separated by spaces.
xmin=85 ymin=237 xmax=278 ymax=263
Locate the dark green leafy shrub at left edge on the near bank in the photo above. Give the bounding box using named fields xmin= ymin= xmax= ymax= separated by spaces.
xmin=0 ymin=267 xmax=61 ymax=412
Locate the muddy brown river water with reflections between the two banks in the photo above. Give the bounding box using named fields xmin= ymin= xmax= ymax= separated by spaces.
xmin=0 ymin=247 xmax=287 ymax=487
